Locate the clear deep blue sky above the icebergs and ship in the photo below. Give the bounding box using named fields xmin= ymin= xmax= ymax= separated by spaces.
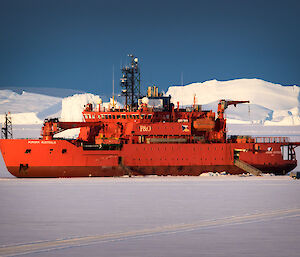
xmin=0 ymin=0 xmax=300 ymax=94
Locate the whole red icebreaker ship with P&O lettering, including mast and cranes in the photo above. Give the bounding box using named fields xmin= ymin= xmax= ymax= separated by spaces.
xmin=0 ymin=55 xmax=300 ymax=177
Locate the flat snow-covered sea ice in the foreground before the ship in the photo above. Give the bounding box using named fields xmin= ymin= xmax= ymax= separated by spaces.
xmin=0 ymin=176 xmax=300 ymax=257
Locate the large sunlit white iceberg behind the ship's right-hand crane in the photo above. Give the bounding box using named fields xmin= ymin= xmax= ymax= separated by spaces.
xmin=166 ymin=79 xmax=300 ymax=126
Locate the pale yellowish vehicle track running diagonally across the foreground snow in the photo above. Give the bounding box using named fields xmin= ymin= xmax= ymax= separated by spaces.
xmin=0 ymin=208 xmax=300 ymax=257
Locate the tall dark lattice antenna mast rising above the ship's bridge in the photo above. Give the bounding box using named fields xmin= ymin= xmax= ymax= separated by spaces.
xmin=120 ymin=54 xmax=141 ymax=110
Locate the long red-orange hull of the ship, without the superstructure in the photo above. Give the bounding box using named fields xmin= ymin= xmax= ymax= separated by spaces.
xmin=0 ymin=139 xmax=297 ymax=178
